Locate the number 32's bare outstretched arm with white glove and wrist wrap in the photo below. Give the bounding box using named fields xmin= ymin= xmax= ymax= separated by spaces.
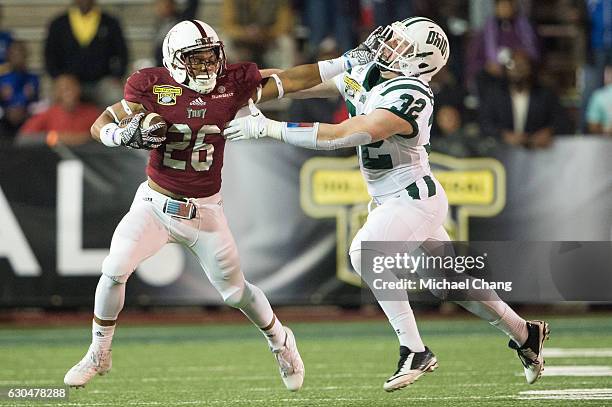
xmin=224 ymin=101 xmax=413 ymax=150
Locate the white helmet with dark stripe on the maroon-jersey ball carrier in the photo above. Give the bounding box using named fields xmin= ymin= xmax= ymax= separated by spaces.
xmin=162 ymin=20 xmax=226 ymax=93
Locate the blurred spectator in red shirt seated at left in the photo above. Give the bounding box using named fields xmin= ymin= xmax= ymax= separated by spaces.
xmin=19 ymin=74 xmax=101 ymax=144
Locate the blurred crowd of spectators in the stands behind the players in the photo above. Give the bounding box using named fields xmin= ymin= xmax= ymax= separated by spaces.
xmin=0 ymin=0 xmax=612 ymax=153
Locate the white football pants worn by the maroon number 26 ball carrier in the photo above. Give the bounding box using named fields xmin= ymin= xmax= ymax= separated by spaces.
xmin=94 ymin=182 xmax=273 ymax=327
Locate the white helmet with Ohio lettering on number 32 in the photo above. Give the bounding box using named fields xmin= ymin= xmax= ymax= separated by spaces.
xmin=374 ymin=17 xmax=450 ymax=81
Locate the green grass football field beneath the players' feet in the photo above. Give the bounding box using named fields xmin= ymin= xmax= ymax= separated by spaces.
xmin=0 ymin=316 xmax=612 ymax=407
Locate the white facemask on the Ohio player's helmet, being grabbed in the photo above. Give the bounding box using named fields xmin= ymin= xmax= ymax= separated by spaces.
xmin=374 ymin=22 xmax=419 ymax=76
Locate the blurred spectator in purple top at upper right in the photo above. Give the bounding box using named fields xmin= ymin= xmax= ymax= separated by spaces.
xmin=467 ymin=0 xmax=540 ymax=94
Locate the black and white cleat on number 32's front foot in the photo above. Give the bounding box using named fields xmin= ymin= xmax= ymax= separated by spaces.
xmin=383 ymin=346 xmax=438 ymax=391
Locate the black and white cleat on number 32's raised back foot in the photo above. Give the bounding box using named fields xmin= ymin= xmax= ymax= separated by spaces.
xmin=508 ymin=321 xmax=550 ymax=384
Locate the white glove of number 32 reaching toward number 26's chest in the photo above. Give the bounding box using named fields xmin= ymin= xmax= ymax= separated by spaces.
xmin=223 ymin=99 xmax=281 ymax=141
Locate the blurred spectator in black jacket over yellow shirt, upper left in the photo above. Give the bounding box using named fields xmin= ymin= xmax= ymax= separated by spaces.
xmin=45 ymin=0 xmax=128 ymax=106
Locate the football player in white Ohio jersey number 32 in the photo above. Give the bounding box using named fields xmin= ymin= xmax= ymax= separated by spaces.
xmin=225 ymin=17 xmax=549 ymax=391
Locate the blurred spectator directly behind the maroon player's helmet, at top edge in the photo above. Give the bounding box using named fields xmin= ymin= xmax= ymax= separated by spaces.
xmin=153 ymin=0 xmax=200 ymax=66
